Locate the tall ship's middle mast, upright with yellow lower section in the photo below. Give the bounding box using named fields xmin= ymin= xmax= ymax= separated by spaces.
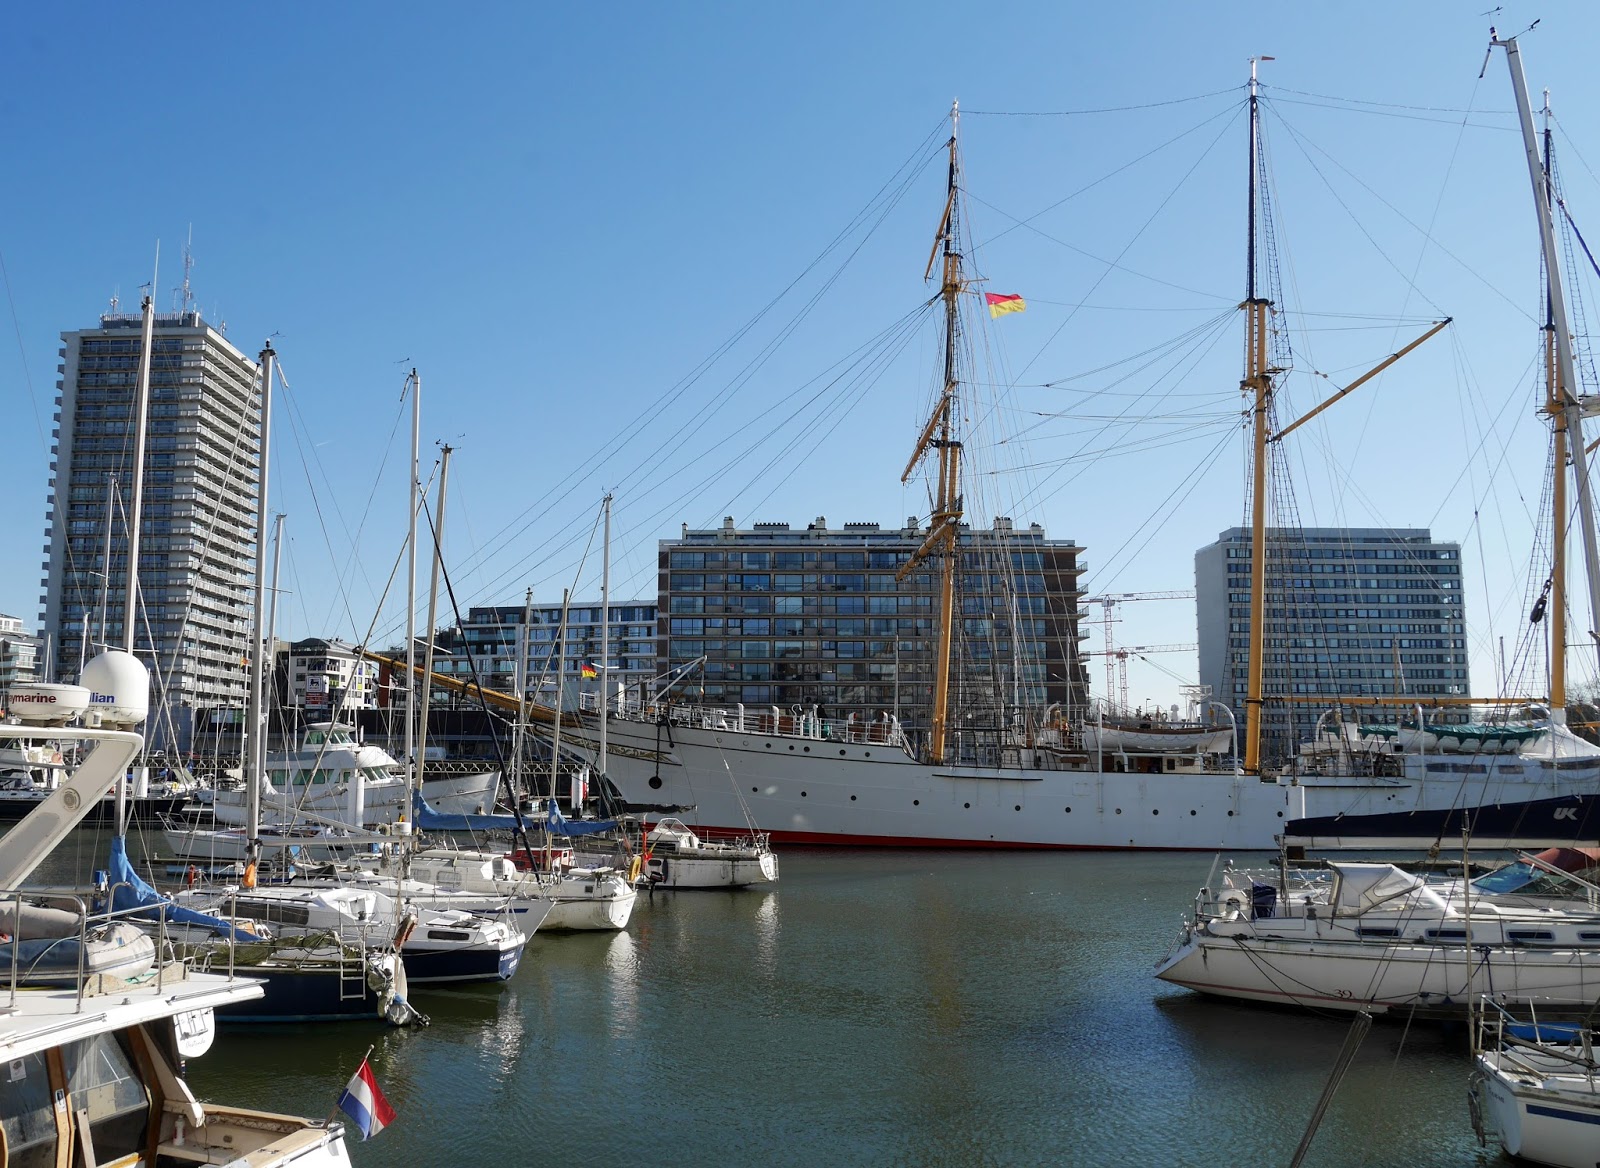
xmin=1240 ymin=58 xmax=1272 ymax=774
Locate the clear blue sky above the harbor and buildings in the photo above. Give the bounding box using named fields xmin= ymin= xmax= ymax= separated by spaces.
xmin=0 ymin=0 xmax=1600 ymax=701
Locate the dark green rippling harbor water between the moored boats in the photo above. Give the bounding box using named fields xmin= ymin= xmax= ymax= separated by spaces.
xmin=62 ymin=832 xmax=1484 ymax=1168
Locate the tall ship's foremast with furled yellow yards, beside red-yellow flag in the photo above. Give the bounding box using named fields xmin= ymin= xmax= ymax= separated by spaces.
xmin=894 ymin=102 xmax=962 ymax=763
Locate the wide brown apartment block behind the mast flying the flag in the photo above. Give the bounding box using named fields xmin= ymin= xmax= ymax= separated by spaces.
xmin=658 ymin=518 xmax=1088 ymax=745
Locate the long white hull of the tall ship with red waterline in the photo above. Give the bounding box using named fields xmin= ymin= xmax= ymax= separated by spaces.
xmin=562 ymin=709 xmax=1600 ymax=851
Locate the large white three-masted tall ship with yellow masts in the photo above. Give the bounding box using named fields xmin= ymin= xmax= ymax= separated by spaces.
xmin=544 ymin=75 xmax=1600 ymax=850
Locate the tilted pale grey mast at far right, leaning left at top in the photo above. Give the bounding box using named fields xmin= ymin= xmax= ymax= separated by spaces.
xmin=1490 ymin=29 xmax=1600 ymax=678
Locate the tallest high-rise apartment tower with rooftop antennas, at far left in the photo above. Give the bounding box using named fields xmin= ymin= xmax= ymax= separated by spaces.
xmin=40 ymin=312 xmax=261 ymax=725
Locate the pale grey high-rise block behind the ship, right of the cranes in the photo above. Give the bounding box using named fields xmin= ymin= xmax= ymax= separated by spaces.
xmin=1195 ymin=528 xmax=1470 ymax=758
